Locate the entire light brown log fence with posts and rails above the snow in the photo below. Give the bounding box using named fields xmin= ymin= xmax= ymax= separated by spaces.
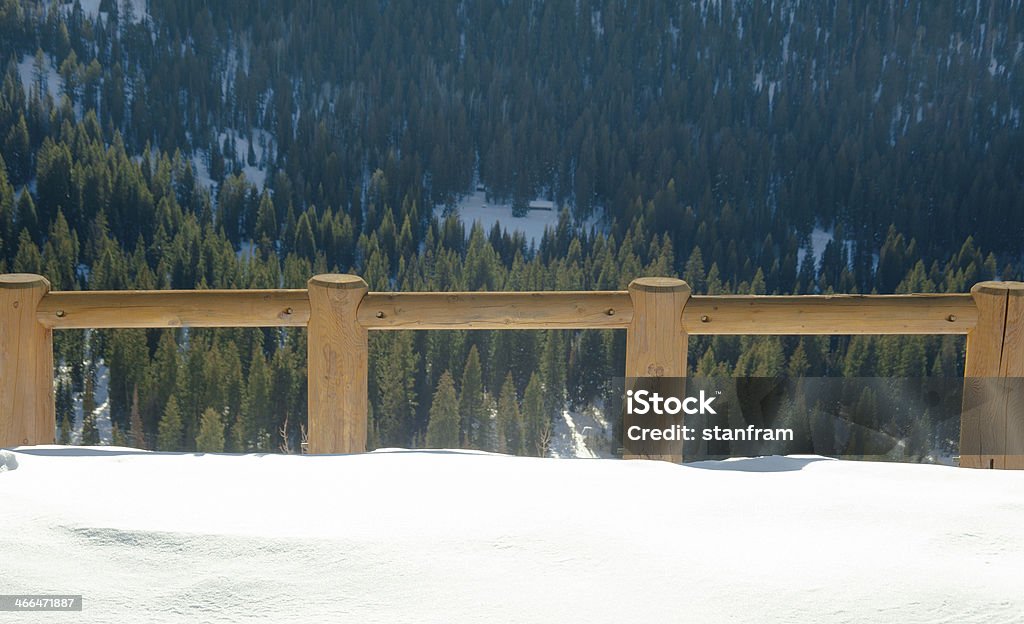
xmin=0 ymin=274 xmax=1024 ymax=468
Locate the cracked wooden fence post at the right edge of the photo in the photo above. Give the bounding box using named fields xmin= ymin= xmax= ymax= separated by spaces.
xmin=959 ymin=282 xmax=1024 ymax=469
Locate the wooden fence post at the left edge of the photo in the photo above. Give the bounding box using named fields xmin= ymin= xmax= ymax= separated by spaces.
xmin=0 ymin=274 xmax=56 ymax=447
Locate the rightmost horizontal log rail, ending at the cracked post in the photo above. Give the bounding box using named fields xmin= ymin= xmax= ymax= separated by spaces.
xmin=683 ymin=294 xmax=978 ymax=336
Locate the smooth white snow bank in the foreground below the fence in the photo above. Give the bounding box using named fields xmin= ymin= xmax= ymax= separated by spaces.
xmin=0 ymin=447 xmax=1024 ymax=623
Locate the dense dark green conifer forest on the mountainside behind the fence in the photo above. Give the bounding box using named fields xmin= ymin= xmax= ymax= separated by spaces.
xmin=0 ymin=0 xmax=1024 ymax=454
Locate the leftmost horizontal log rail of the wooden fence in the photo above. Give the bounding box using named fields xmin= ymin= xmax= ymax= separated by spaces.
xmin=37 ymin=289 xmax=309 ymax=329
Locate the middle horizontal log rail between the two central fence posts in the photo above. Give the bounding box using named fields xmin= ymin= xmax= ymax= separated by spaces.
xmin=358 ymin=291 xmax=633 ymax=330
